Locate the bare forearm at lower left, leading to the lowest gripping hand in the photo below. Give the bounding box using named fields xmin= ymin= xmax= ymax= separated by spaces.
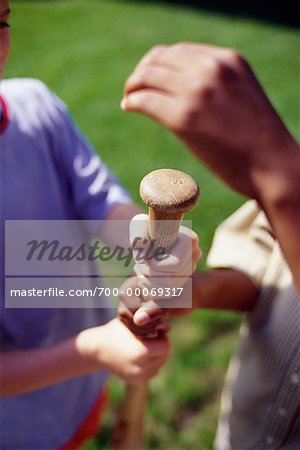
xmin=0 ymin=337 xmax=95 ymax=396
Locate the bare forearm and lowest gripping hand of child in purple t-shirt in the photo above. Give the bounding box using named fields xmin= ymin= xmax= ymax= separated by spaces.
xmin=0 ymin=319 xmax=170 ymax=396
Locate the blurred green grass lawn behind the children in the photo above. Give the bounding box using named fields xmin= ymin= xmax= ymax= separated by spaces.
xmin=6 ymin=0 xmax=300 ymax=450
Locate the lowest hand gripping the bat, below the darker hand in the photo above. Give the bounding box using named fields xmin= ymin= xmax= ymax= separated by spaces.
xmin=77 ymin=319 xmax=171 ymax=383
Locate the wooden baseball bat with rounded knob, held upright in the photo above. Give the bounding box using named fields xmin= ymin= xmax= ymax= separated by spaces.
xmin=112 ymin=169 xmax=199 ymax=450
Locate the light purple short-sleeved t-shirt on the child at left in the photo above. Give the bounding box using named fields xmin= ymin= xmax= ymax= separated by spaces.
xmin=0 ymin=79 xmax=131 ymax=450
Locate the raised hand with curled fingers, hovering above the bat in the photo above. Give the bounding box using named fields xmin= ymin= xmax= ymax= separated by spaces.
xmin=121 ymin=43 xmax=298 ymax=198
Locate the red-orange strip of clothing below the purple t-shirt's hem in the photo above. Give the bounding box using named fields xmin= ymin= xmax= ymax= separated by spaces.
xmin=59 ymin=388 xmax=109 ymax=450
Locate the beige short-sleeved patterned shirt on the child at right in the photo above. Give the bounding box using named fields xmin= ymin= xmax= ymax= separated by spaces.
xmin=208 ymin=201 xmax=300 ymax=450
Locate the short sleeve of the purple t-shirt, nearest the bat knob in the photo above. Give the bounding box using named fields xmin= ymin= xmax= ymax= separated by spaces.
xmin=36 ymin=88 xmax=132 ymax=229
